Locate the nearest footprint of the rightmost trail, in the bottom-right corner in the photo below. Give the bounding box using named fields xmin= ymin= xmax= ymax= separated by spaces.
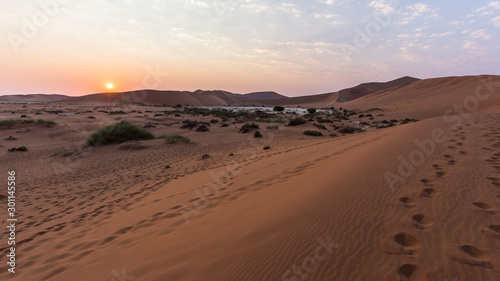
xmin=445 ymin=245 xmax=493 ymax=269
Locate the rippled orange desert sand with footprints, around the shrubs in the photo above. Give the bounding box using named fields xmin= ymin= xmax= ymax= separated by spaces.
xmin=0 ymin=76 xmax=500 ymax=281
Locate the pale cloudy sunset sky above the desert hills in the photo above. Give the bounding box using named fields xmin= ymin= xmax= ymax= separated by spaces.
xmin=0 ymin=0 xmax=500 ymax=96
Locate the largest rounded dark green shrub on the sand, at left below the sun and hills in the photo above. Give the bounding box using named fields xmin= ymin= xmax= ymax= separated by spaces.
xmin=85 ymin=123 xmax=155 ymax=146
